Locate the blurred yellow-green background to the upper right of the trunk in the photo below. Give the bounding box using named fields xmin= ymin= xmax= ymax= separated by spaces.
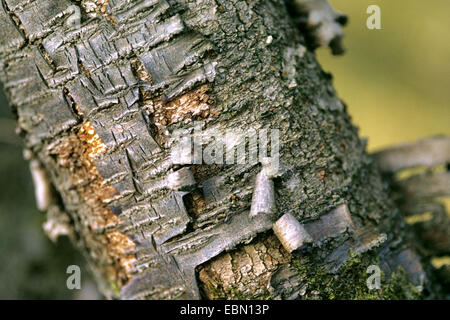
xmin=318 ymin=0 xmax=450 ymax=151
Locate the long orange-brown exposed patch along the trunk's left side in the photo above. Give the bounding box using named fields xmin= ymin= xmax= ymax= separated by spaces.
xmin=50 ymin=121 xmax=135 ymax=286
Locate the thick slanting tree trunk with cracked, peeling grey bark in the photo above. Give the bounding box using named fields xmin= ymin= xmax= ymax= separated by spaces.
xmin=0 ymin=0 xmax=448 ymax=299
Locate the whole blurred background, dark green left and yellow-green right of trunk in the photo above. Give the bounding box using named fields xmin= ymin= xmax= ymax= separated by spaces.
xmin=0 ymin=0 xmax=450 ymax=299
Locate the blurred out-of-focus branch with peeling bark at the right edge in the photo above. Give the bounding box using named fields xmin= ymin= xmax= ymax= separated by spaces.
xmin=374 ymin=136 xmax=450 ymax=258
